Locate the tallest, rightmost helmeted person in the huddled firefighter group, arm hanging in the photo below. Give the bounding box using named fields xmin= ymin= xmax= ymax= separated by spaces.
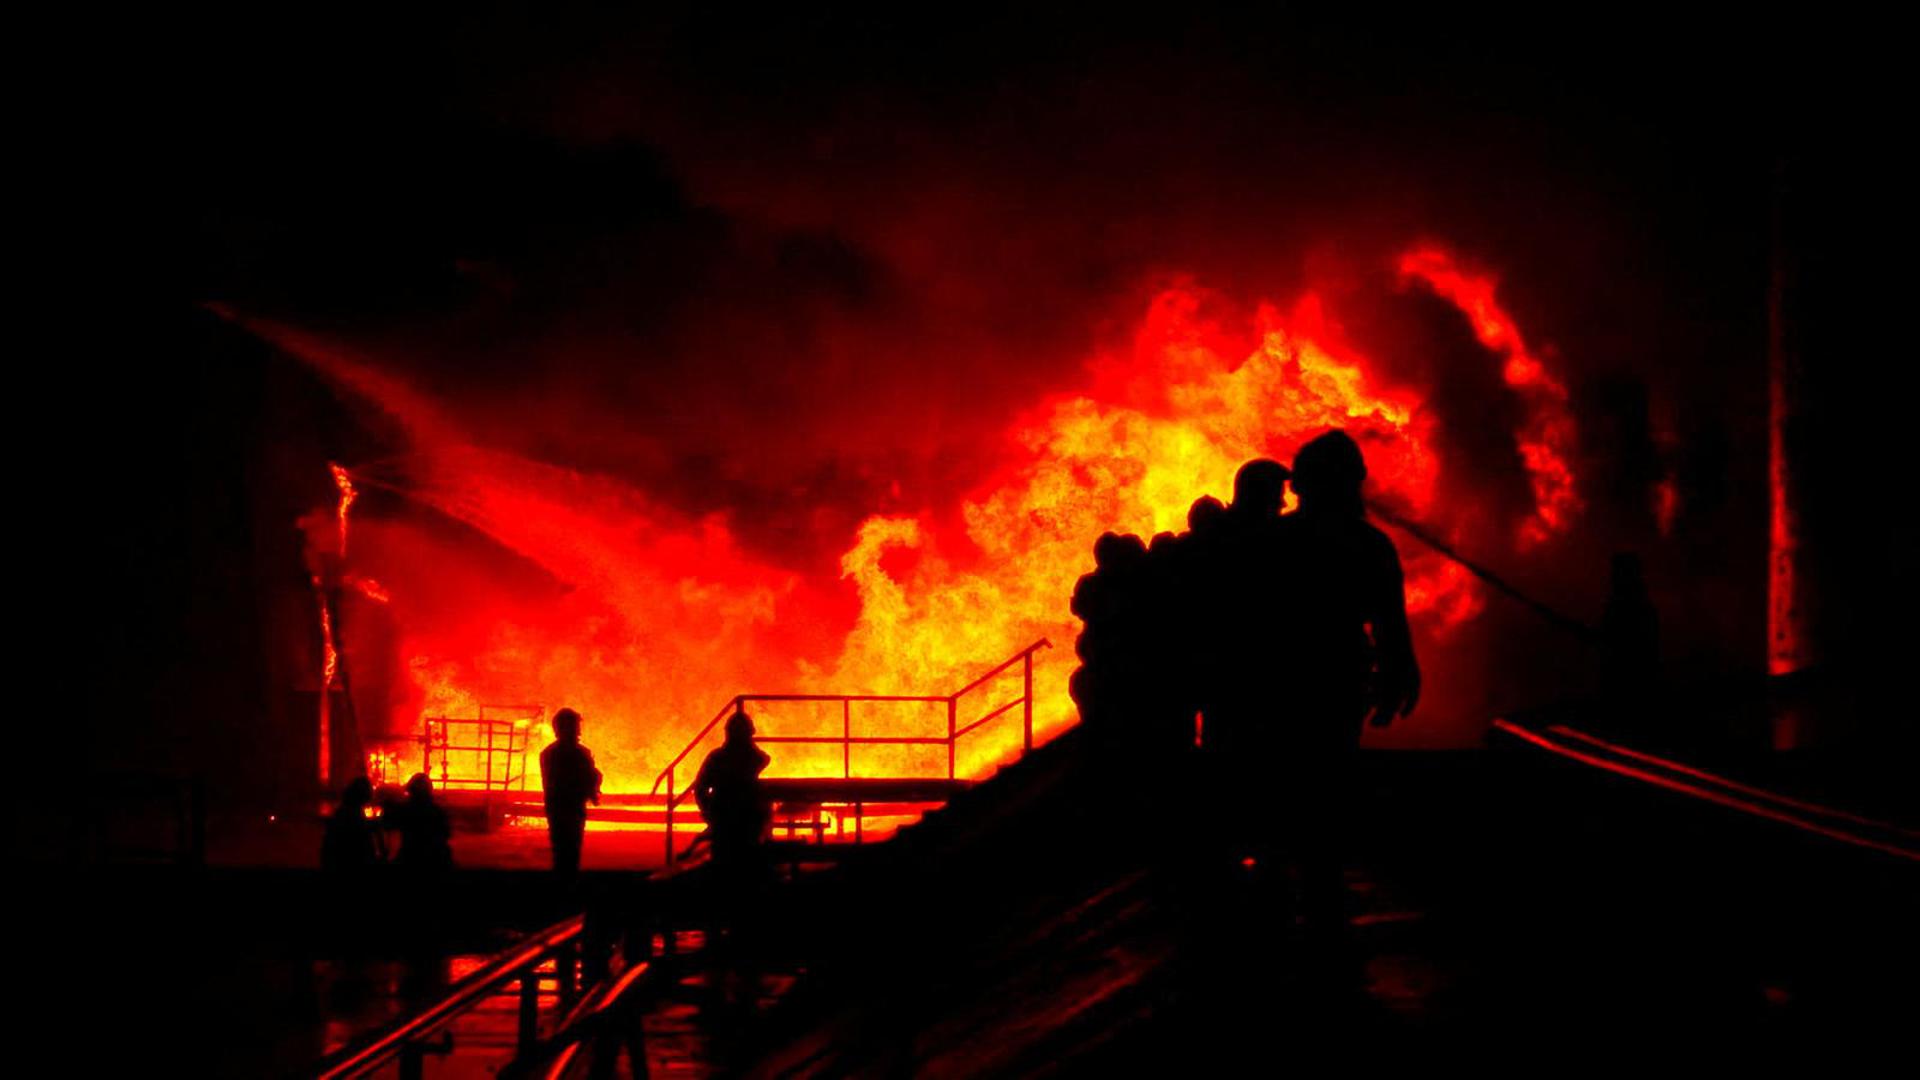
xmin=1279 ymin=430 xmax=1421 ymax=930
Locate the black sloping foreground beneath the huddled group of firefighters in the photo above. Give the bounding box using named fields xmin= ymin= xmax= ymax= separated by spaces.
xmin=728 ymin=736 xmax=1920 ymax=1074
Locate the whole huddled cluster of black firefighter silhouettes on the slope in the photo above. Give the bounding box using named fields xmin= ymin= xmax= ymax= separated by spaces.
xmin=1071 ymin=430 xmax=1421 ymax=928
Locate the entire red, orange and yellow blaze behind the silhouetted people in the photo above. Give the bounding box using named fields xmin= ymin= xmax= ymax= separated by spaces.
xmin=248 ymin=248 xmax=1580 ymax=790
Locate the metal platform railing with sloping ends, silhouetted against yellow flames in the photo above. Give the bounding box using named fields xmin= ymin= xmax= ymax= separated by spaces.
xmin=651 ymin=638 xmax=1052 ymax=863
